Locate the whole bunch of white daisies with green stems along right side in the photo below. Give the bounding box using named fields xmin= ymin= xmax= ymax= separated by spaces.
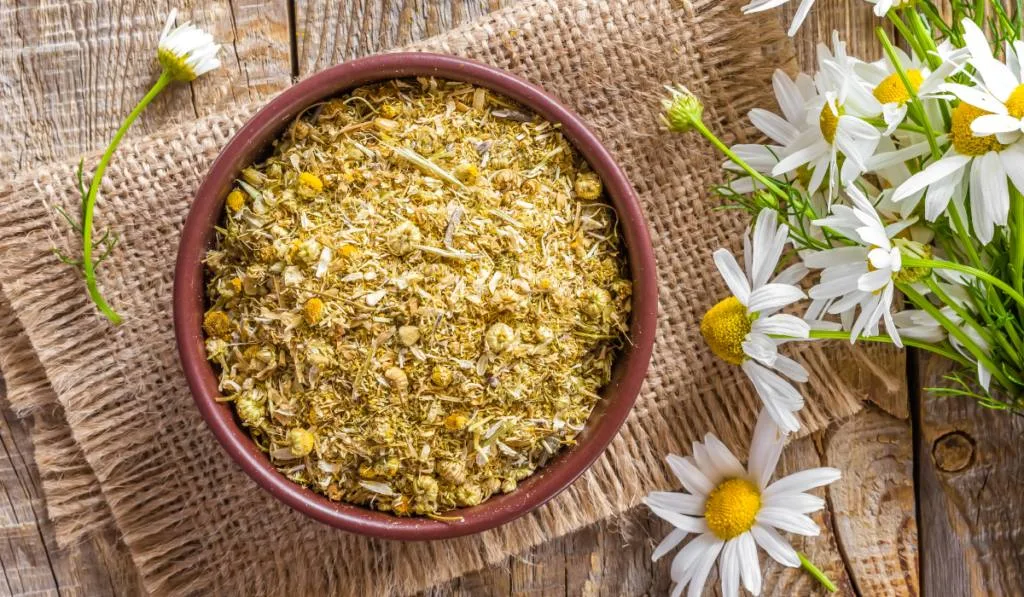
xmin=644 ymin=0 xmax=1024 ymax=597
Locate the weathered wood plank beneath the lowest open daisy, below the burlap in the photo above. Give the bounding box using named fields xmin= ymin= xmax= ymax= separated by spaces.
xmin=450 ymin=409 xmax=919 ymax=597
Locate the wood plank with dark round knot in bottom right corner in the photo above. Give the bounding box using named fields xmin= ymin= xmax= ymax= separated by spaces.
xmin=918 ymin=357 xmax=1024 ymax=597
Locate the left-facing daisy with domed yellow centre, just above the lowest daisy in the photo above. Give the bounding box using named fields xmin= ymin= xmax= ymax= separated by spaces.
xmin=700 ymin=209 xmax=810 ymax=431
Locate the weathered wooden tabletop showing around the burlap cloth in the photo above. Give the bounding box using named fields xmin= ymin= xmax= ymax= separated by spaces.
xmin=0 ymin=0 xmax=1024 ymax=597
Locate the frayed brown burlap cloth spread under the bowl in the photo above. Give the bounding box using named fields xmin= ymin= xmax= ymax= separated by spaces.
xmin=0 ymin=0 xmax=897 ymax=596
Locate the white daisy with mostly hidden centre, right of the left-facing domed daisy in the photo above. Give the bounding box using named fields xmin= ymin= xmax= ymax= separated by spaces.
xmin=802 ymin=186 xmax=916 ymax=346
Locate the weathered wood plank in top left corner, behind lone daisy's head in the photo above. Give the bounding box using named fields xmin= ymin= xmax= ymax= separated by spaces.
xmin=0 ymin=0 xmax=291 ymax=169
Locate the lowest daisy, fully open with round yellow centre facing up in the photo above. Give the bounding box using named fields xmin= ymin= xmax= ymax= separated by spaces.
xmin=644 ymin=411 xmax=840 ymax=597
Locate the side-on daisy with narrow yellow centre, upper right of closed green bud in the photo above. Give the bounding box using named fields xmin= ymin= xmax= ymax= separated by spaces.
xmin=772 ymin=33 xmax=882 ymax=198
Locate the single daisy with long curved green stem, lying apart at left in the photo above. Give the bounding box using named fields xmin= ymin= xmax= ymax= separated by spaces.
xmin=61 ymin=10 xmax=220 ymax=325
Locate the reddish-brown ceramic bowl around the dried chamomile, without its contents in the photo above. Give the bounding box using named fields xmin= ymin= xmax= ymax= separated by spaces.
xmin=174 ymin=53 xmax=657 ymax=540
